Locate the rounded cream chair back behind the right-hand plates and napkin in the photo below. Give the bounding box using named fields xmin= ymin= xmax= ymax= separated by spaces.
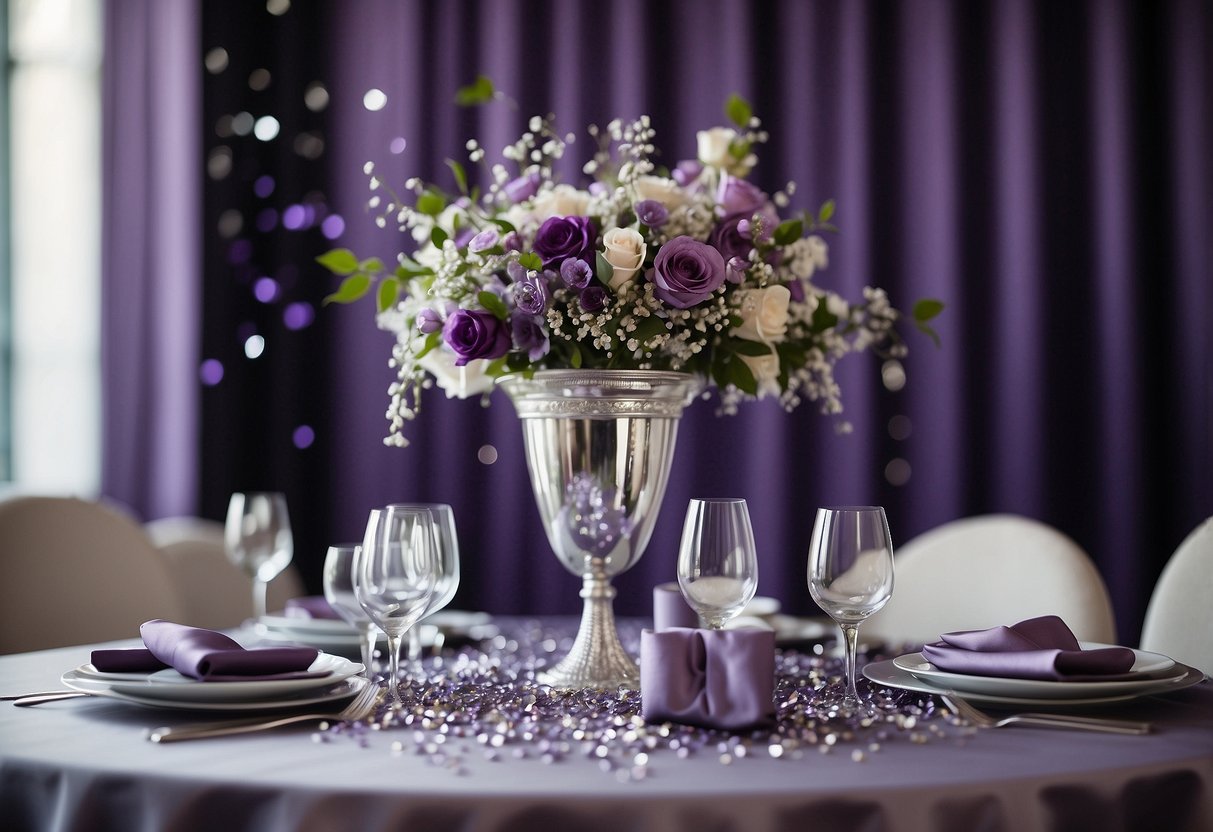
xmin=860 ymin=514 xmax=1116 ymax=644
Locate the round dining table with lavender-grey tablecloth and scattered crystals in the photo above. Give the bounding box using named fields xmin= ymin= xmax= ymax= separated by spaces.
xmin=0 ymin=617 xmax=1213 ymax=832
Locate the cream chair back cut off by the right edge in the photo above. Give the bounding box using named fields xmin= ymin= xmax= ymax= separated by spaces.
xmin=1141 ymin=517 xmax=1213 ymax=673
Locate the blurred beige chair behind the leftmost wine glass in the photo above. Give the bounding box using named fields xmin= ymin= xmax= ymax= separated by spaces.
xmin=143 ymin=517 xmax=304 ymax=629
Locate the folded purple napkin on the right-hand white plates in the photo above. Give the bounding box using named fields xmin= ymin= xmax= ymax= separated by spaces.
xmin=922 ymin=615 xmax=1134 ymax=682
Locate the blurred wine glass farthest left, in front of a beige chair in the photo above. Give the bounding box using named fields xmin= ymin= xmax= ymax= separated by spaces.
xmin=223 ymin=491 xmax=295 ymax=621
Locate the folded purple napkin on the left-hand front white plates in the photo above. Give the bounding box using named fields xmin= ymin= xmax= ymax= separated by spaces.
xmin=92 ymin=619 xmax=328 ymax=682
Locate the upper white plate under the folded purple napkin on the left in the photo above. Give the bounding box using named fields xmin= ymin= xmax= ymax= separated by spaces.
xmin=64 ymin=653 xmax=363 ymax=703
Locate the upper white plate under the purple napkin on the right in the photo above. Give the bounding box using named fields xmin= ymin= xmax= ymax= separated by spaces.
xmin=893 ymin=643 xmax=1181 ymax=699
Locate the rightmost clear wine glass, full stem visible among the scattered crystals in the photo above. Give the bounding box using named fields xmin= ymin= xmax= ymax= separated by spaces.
xmin=809 ymin=506 xmax=893 ymax=713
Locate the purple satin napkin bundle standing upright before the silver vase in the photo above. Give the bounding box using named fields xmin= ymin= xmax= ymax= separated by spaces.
xmin=640 ymin=627 xmax=775 ymax=730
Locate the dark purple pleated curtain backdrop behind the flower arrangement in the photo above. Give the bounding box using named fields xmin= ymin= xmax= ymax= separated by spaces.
xmin=99 ymin=0 xmax=1213 ymax=643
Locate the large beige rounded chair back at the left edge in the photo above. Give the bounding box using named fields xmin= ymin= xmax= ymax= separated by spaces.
xmin=0 ymin=496 xmax=183 ymax=653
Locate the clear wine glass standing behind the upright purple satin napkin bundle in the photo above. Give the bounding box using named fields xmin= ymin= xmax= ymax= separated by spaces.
xmin=678 ymin=498 xmax=758 ymax=629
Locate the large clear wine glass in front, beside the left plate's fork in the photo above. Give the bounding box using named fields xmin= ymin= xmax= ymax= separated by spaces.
xmin=354 ymin=506 xmax=443 ymax=705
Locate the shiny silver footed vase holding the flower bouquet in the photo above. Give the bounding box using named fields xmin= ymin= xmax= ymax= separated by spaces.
xmin=497 ymin=370 xmax=701 ymax=689
